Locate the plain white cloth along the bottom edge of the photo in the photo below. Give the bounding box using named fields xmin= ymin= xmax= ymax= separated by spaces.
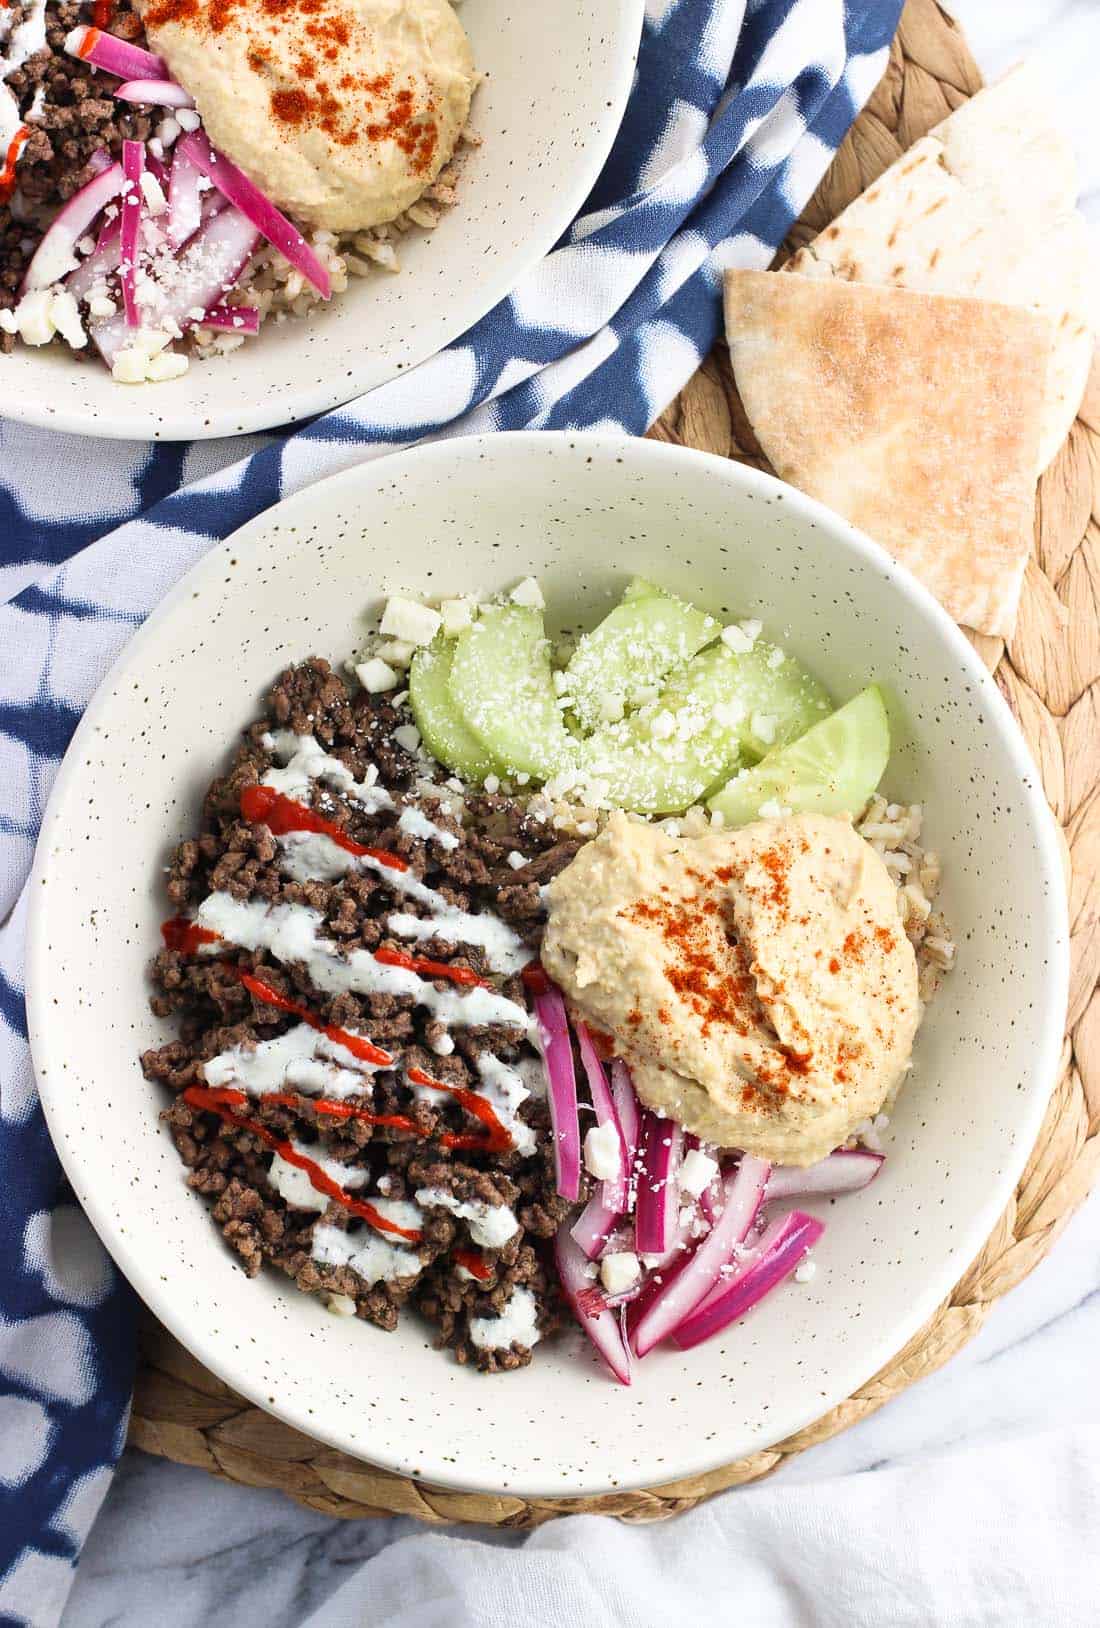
xmin=306 ymin=1426 xmax=1100 ymax=1628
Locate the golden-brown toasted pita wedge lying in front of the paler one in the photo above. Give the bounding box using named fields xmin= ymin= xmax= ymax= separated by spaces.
xmin=726 ymin=272 xmax=1051 ymax=637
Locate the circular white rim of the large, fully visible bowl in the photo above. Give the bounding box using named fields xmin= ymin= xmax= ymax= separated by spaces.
xmin=26 ymin=430 xmax=1069 ymax=1498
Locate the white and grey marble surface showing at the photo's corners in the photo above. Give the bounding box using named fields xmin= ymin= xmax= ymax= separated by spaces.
xmin=63 ymin=0 xmax=1100 ymax=1628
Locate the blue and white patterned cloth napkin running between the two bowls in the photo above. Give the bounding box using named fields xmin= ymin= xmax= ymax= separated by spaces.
xmin=0 ymin=0 xmax=901 ymax=1628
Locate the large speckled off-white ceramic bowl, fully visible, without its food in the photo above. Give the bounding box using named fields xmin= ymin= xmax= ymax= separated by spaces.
xmin=29 ymin=435 xmax=1067 ymax=1495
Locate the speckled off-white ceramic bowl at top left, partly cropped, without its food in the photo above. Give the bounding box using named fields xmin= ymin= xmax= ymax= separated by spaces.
xmin=0 ymin=0 xmax=643 ymax=441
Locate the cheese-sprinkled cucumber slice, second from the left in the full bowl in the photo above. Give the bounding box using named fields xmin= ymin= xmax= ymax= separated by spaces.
xmin=449 ymin=606 xmax=573 ymax=780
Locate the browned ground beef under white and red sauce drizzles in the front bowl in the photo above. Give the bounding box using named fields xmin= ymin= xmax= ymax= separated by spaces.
xmin=142 ymin=659 xmax=578 ymax=1371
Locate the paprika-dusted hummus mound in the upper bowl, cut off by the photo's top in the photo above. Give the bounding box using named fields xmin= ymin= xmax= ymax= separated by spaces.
xmin=138 ymin=0 xmax=477 ymax=231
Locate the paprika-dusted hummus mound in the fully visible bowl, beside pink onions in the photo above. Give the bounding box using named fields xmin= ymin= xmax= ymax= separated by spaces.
xmin=542 ymin=814 xmax=921 ymax=1164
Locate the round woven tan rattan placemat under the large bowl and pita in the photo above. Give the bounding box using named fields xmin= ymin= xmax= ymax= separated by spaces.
xmin=130 ymin=0 xmax=1100 ymax=1527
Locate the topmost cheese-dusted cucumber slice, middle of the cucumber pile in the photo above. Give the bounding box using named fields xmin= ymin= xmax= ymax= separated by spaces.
xmin=565 ymin=576 xmax=719 ymax=731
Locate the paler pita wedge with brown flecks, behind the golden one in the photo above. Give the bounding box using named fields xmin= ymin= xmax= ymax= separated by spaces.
xmin=784 ymin=65 xmax=1100 ymax=472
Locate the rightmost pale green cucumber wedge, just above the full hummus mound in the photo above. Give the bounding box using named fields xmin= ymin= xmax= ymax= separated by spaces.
xmin=708 ymin=684 xmax=890 ymax=825
